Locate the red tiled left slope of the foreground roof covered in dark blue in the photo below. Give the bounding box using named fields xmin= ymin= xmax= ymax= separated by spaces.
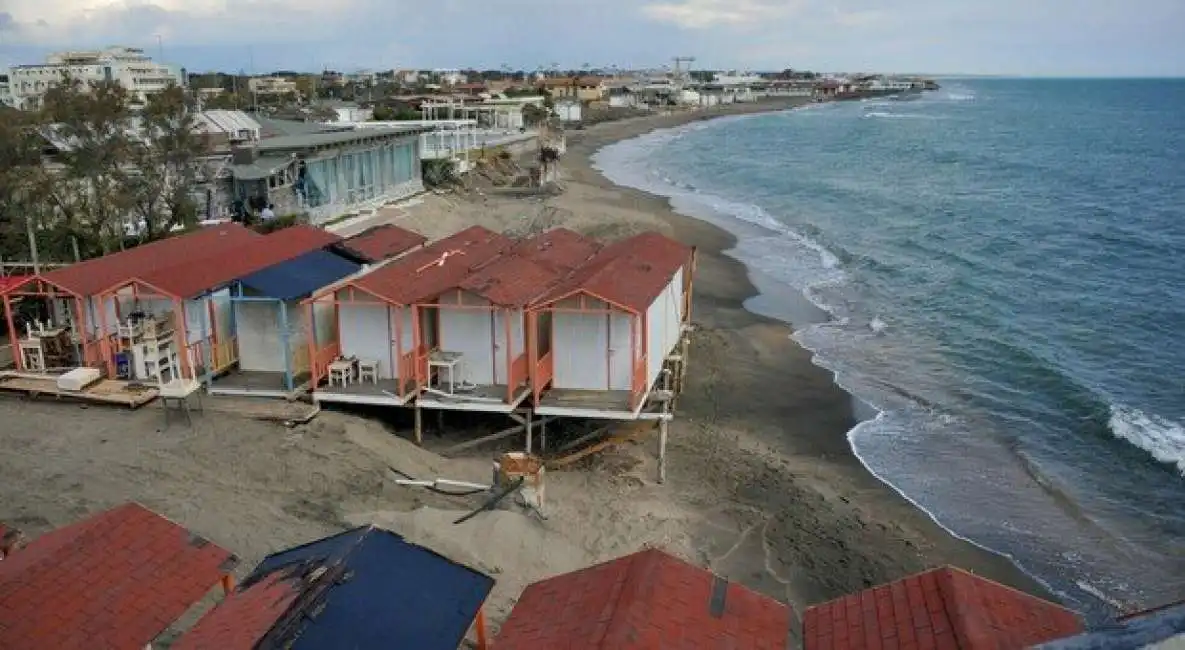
xmin=172 ymin=573 xmax=301 ymax=650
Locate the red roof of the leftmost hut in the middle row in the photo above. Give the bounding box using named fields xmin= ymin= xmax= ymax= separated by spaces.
xmin=41 ymin=223 xmax=260 ymax=296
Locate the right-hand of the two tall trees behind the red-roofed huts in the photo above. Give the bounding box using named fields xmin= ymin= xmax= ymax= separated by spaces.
xmin=127 ymin=85 xmax=205 ymax=240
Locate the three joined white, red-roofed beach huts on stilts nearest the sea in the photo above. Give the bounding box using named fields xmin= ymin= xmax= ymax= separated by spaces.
xmin=303 ymin=226 xmax=694 ymax=419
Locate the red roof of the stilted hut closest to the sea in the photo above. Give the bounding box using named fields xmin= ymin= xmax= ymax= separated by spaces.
xmin=538 ymin=232 xmax=692 ymax=313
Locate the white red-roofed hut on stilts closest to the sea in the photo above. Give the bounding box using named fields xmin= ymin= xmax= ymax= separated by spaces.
xmin=527 ymin=232 xmax=694 ymax=419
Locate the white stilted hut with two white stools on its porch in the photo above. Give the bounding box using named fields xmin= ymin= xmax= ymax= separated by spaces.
xmin=305 ymin=226 xmax=513 ymax=406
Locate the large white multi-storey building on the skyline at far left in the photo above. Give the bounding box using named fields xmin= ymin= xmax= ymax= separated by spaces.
xmin=8 ymin=47 xmax=185 ymax=109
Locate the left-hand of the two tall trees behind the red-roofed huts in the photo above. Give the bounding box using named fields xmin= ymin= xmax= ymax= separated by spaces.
xmin=40 ymin=77 xmax=132 ymax=252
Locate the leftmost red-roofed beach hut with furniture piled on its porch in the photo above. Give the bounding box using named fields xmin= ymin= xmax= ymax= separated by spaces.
xmin=0 ymin=224 xmax=260 ymax=374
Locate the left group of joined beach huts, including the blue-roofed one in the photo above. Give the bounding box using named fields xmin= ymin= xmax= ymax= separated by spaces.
xmin=2 ymin=224 xmax=424 ymax=397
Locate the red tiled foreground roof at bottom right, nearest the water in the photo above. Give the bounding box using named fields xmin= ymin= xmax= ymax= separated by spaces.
xmin=802 ymin=567 xmax=1083 ymax=650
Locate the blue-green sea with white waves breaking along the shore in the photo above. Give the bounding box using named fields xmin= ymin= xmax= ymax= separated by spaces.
xmin=595 ymin=78 xmax=1185 ymax=620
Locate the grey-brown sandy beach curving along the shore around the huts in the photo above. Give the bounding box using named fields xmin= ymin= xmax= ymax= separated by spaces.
xmin=0 ymin=97 xmax=1040 ymax=644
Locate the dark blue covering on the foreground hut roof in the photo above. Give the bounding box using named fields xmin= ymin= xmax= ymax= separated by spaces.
xmin=252 ymin=527 xmax=494 ymax=650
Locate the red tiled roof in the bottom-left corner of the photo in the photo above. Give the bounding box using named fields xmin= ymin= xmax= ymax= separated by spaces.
xmin=0 ymin=503 xmax=236 ymax=650
